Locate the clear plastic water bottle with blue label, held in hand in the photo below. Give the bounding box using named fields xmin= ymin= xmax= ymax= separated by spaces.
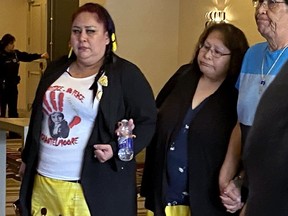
xmin=118 ymin=119 xmax=134 ymax=161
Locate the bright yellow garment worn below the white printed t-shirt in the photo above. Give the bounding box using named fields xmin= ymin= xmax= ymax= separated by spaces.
xmin=31 ymin=175 xmax=90 ymax=216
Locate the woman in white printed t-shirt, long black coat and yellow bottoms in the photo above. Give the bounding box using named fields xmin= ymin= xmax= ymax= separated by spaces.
xmin=20 ymin=3 xmax=157 ymax=216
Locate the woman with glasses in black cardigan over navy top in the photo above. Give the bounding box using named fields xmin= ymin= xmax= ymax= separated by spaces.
xmin=141 ymin=23 xmax=248 ymax=216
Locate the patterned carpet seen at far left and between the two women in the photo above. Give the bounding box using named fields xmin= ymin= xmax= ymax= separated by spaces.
xmin=6 ymin=139 xmax=146 ymax=216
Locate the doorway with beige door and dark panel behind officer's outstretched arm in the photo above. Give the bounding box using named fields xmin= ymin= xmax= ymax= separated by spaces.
xmin=26 ymin=0 xmax=79 ymax=112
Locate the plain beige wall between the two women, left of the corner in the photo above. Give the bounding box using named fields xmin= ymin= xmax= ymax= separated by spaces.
xmin=80 ymin=0 xmax=179 ymax=95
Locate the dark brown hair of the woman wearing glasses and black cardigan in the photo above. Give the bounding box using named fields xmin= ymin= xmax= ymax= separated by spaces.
xmin=192 ymin=23 xmax=249 ymax=82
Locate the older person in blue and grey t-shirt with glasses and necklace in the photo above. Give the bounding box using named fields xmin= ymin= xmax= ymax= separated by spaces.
xmin=219 ymin=0 xmax=288 ymax=215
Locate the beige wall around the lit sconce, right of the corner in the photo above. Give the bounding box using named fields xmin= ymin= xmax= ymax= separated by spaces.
xmin=178 ymin=0 xmax=263 ymax=64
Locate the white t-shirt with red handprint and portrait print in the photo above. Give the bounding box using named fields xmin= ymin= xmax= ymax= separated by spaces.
xmin=37 ymin=72 xmax=102 ymax=180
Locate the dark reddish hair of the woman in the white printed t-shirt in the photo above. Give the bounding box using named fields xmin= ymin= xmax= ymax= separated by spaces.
xmin=72 ymin=3 xmax=116 ymax=56
